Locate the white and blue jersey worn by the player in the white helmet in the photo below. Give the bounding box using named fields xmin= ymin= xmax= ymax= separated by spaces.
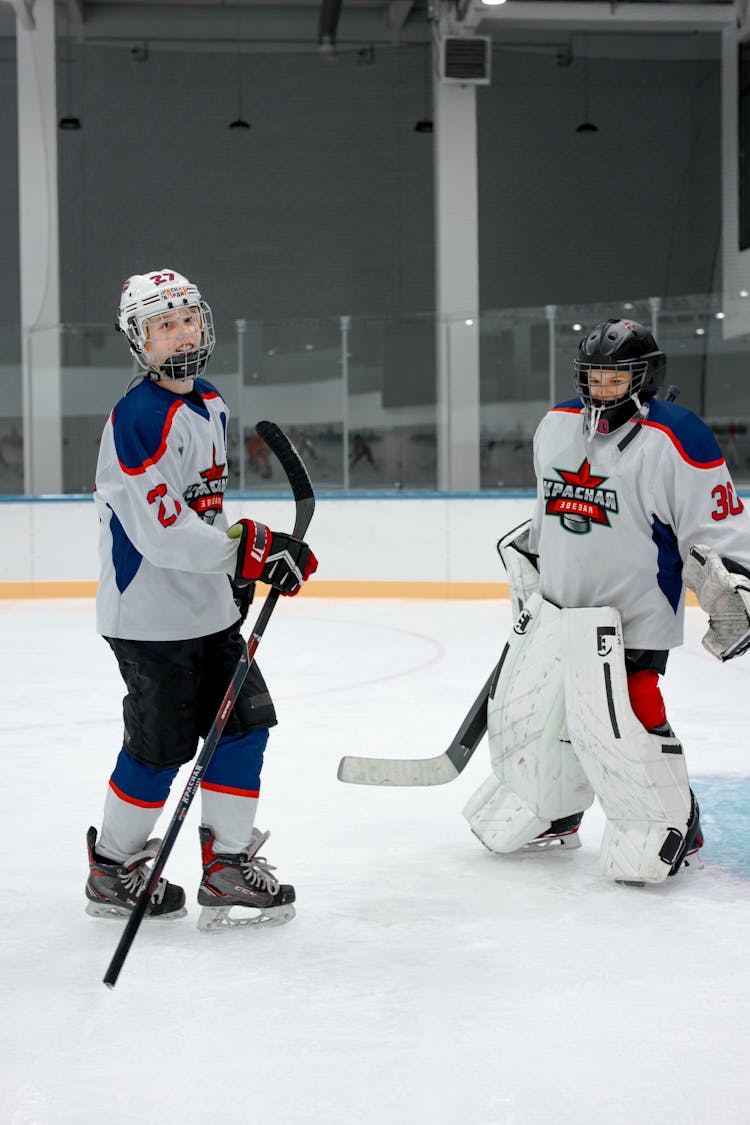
xmin=93 ymin=378 xmax=238 ymax=640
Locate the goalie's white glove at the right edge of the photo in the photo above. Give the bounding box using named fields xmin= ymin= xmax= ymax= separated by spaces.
xmin=683 ymin=543 xmax=750 ymax=660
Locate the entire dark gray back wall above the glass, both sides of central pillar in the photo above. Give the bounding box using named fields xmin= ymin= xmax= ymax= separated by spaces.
xmin=0 ymin=23 xmax=720 ymax=323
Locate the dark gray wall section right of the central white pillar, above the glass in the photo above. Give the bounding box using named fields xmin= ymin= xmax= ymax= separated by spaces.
xmin=478 ymin=46 xmax=721 ymax=308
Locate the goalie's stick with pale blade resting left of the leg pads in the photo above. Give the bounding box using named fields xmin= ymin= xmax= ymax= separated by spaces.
xmin=338 ymin=653 xmax=505 ymax=785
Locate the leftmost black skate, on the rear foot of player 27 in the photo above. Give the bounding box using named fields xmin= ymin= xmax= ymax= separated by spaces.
xmin=85 ymin=828 xmax=188 ymax=919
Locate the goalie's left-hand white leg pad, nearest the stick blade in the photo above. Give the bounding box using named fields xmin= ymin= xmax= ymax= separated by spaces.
xmin=463 ymin=593 xmax=594 ymax=853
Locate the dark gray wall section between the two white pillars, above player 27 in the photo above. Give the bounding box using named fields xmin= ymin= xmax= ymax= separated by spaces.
xmin=60 ymin=45 xmax=433 ymax=321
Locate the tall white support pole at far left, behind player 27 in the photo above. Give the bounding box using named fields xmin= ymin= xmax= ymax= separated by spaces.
xmin=16 ymin=0 xmax=63 ymax=495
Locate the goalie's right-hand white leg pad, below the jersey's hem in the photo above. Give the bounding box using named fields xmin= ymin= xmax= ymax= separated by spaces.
xmin=561 ymin=608 xmax=692 ymax=883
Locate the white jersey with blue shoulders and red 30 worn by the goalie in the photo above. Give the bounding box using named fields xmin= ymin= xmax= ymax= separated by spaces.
xmin=530 ymin=398 xmax=750 ymax=649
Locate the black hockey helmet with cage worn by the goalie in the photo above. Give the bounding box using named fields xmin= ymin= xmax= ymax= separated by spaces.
xmin=575 ymin=320 xmax=667 ymax=437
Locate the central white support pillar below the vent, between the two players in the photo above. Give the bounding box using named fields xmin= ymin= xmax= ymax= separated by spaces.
xmin=433 ymin=26 xmax=479 ymax=492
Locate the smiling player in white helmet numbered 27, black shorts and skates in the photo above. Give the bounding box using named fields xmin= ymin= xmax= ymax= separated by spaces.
xmin=85 ymin=269 xmax=317 ymax=929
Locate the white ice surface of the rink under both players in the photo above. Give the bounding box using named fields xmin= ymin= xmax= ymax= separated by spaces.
xmin=0 ymin=599 xmax=750 ymax=1125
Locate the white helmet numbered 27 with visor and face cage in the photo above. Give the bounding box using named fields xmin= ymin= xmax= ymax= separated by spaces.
xmin=116 ymin=270 xmax=216 ymax=379
